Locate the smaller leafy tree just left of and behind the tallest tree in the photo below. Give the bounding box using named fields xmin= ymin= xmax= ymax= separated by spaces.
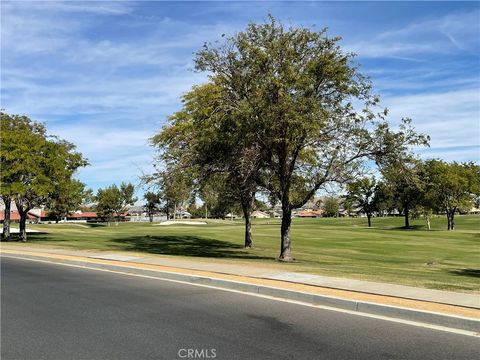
xmin=152 ymin=82 xmax=261 ymax=247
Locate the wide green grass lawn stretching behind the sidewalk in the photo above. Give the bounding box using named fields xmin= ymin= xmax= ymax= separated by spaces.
xmin=8 ymin=215 xmax=480 ymax=291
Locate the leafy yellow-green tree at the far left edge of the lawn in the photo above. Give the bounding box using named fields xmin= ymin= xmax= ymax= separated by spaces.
xmin=1 ymin=113 xmax=87 ymax=241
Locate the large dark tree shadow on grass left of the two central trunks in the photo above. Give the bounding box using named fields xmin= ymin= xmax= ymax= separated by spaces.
xmin=112 ymin=235 xmax=273 ymax=260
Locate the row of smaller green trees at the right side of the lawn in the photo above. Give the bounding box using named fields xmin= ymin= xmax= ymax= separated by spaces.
xmin=344 ymin=159 xmax=480 ymax=230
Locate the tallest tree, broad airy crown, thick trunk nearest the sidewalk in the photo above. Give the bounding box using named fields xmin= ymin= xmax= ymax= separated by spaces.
xmin=195 ymin=17 xmax=425 ymax=261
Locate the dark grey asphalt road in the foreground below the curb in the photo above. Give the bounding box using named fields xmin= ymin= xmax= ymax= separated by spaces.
xmin=1 ymin=257 xmax=480 ymax=360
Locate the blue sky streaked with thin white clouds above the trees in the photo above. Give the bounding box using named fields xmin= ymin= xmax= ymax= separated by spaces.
xmin=1 ymin=1 xmax=480 ymax=197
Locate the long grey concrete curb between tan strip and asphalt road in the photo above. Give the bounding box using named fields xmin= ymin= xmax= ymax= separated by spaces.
xmin=2 ymin=253 xmax=480 ymax=333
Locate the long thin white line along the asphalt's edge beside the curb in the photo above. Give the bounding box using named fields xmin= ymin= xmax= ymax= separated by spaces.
xmin=0 ymin=253 xmax=480 ymax=337
